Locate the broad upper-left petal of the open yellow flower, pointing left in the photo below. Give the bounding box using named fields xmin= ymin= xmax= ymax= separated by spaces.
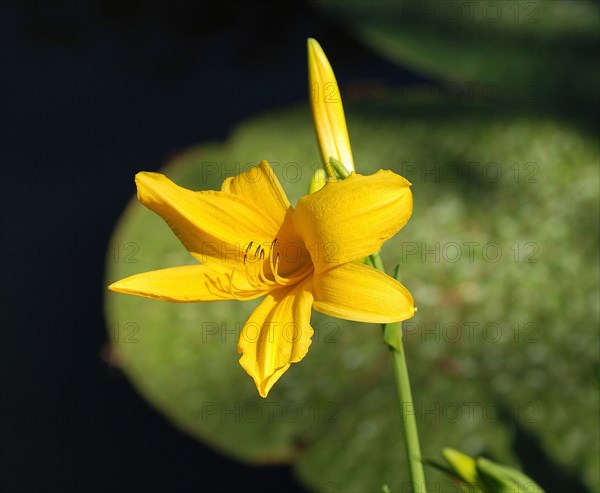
xmin=136 ymin=165 xmax=280 ymax=263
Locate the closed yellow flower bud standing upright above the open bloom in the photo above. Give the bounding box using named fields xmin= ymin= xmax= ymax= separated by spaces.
xmin=308 ymin=38 xmax=354 ymax=172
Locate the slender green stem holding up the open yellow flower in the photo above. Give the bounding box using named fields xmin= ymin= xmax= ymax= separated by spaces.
xmin=370 ymin=253 xmax=427 ymax=493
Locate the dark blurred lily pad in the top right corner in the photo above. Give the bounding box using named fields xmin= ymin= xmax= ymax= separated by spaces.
xmin=315 ymin=0 xmax=600 ymax=121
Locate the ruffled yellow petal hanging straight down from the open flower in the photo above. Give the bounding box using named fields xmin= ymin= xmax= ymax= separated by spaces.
xmin=238 ymin=278 xmax=313 ymax=397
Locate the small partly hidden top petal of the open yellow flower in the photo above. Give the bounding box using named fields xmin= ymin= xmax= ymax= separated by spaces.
xmin=221 ymin=160 xmax=290 ymax=224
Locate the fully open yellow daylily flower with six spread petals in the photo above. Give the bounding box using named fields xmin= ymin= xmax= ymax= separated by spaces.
xmin=109 ymin=161 xmax=415 ymax=397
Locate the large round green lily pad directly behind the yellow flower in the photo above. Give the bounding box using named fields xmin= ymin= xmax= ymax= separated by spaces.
xmin=106 ymin=93 xmax=600 ymax=491
